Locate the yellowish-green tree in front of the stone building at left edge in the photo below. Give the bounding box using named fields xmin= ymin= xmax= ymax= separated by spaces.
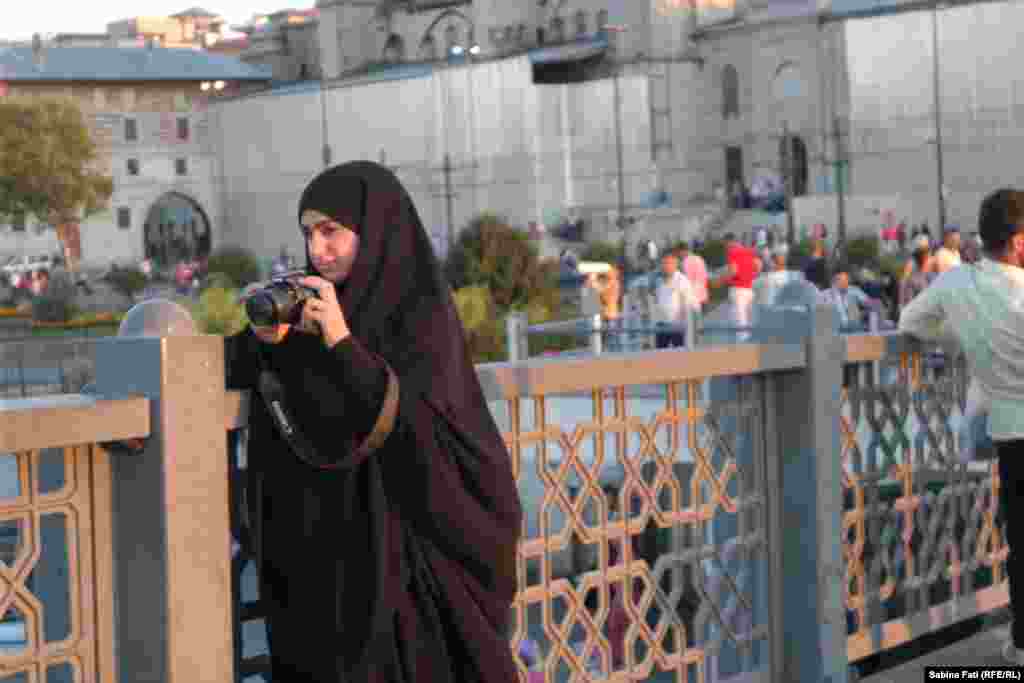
xmin=0 ymin=97 xmax=114 ymax=270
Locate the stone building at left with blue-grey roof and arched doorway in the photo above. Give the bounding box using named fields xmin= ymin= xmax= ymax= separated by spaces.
xmin=0 ymin=47 xmax=268 ymax=266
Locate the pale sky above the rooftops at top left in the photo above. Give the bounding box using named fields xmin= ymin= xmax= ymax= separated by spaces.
xmin=0 ymin=0 xmax=299 ymax=40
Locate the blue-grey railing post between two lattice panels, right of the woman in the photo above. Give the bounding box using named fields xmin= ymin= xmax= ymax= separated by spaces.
xmin=764 ymin=304 xmax=849 ymax=683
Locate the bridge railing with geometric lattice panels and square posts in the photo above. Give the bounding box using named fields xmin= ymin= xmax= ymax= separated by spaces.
xmin=0 ymin=307 xmax=1007 ymax=683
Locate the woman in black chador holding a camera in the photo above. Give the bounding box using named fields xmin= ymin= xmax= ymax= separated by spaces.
xmin=225 ymin=162 xmax=522 ymax=683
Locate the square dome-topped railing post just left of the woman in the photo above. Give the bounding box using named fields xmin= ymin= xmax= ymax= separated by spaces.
xmin=93 ymin=301 xmax=234 ymax=683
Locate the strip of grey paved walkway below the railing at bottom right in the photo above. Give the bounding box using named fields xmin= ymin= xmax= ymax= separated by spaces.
xmin=860 ymin=620 xmax=1010 ymax=683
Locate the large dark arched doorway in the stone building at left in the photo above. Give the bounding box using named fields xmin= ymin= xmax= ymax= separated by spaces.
xmin=142 ymin=193 xmax=211 ymax=268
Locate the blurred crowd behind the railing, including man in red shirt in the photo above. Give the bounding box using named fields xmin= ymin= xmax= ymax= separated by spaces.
xmin=586 ymin=219 xmax=981 ymax=350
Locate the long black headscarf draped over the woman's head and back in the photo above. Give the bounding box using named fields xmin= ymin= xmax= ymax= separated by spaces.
xmin=299 ymin=161 xmax=522 ymax=682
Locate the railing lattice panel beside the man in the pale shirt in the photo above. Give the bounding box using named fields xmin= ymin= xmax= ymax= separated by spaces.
xmin=841 ymin=352 xmax=1008 ymax=660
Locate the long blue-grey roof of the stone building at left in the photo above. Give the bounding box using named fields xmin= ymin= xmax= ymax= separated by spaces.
xmin=0 ymin=47 xmax=271 ymax=82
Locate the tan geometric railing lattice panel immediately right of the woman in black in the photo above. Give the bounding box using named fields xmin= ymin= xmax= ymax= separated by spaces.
xmin=496 ymin=377 xmax=767 ymax=681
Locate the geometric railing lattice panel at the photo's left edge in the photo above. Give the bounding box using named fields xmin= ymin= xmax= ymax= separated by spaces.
xmin=0 ymin=445 xmax=114 ymax=683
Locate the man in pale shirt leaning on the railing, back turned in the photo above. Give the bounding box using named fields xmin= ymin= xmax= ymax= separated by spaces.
xmin=899 ymin=189 xmax=1024 ymax=666
